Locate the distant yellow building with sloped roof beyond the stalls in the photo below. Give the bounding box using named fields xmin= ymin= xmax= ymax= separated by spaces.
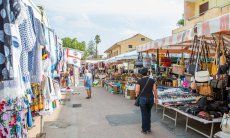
xmin=105 ymin=34 xmax=152 ymax=58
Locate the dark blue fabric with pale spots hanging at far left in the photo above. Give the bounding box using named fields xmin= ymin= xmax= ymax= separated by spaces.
xmin=0 ymin=0 xmax=21 ymax=80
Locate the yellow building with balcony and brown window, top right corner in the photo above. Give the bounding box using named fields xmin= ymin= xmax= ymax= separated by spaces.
xmin=173 ymin=0 xmax=230 ymax=34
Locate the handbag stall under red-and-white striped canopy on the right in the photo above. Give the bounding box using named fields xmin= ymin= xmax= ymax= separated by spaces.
xmin=137 ymin=14 xmax=230 ymax=137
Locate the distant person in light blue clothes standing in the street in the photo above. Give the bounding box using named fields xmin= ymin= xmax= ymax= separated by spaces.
xmin=84 ymin=70 xmax=93 ymax=99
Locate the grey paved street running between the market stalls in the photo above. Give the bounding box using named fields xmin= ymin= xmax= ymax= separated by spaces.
xmin=30 ymin=85 xmax=208 ymax=138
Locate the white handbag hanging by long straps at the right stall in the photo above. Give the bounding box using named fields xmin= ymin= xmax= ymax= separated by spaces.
xmin=195 ymin=38 xmax=210 ymax=82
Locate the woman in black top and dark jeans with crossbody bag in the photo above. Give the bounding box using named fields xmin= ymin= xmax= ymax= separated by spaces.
xmin=136 ymin=68 xmax=157 ymax=134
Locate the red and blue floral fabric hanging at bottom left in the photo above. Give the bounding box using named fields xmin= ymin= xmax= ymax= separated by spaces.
xmin=0 ymin=98 xmax=28 ymax=138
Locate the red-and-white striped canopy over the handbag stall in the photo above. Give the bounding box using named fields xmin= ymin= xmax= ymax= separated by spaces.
xmin=137 ymin=13 xmax=230 ymax=53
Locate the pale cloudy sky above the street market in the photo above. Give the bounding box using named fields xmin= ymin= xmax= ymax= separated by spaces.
xmin=34 ymin=0 xmax=184 ymax=54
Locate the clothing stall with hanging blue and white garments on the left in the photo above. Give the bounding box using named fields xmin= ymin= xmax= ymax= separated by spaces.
xmin=0 ymin=0 xmax=65 ymax=137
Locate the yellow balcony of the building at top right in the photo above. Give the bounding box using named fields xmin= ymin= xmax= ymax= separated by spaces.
xmin=172 ymin=4 xmax=230 ymax=34
